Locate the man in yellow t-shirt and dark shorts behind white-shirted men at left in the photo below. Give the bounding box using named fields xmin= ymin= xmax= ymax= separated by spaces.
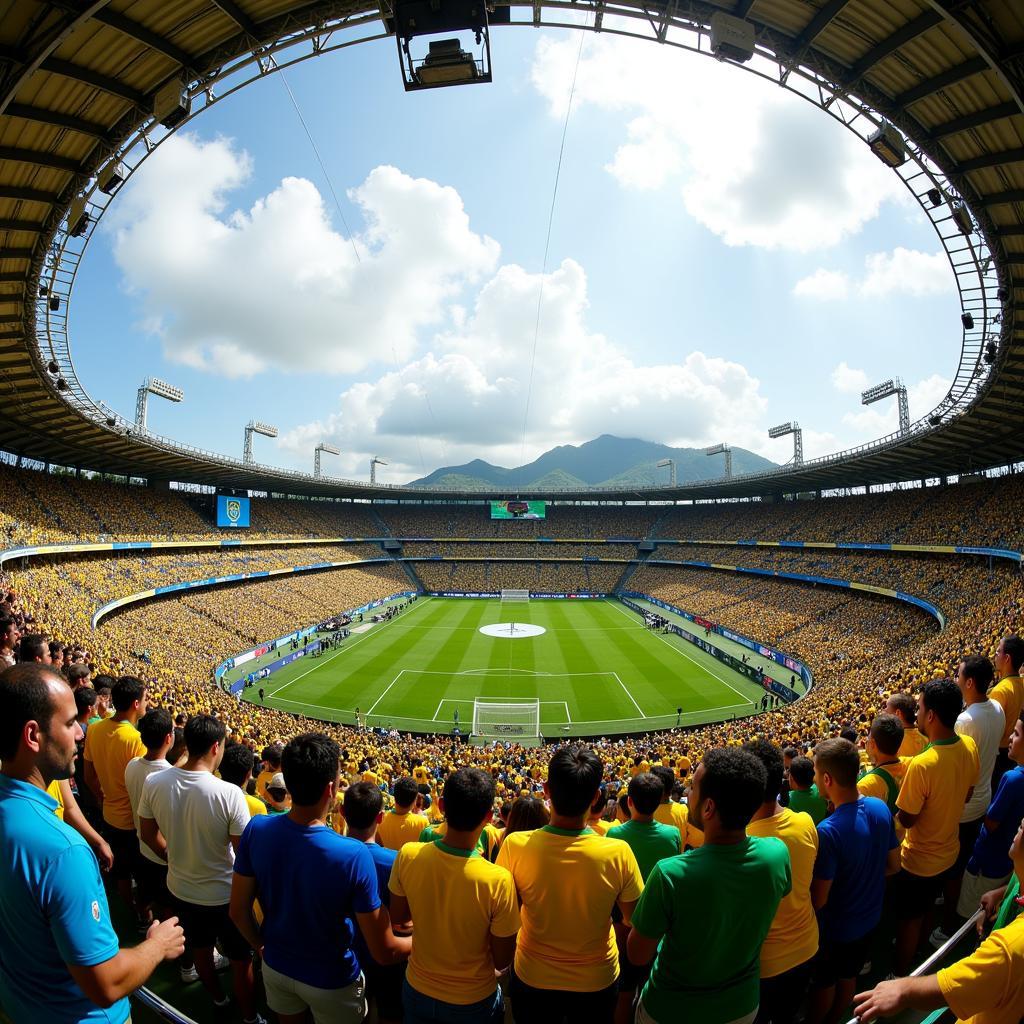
xmin=84 ymin=676 xmax=146 ymax=922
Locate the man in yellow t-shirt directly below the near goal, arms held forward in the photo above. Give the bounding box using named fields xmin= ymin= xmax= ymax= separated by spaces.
xmin=498 ymin=746 xmax=643 ymax=1024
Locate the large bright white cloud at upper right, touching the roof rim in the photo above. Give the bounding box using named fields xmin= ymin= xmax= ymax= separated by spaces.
xmin=531 ymin=36 xmax=905 ymax=251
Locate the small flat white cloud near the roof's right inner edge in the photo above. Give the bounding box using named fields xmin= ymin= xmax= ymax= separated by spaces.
xmin=793 ymin=246 xmax=956 ymax=301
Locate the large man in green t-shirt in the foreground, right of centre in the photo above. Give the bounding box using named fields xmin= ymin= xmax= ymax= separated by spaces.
xmin=628 ymin=748 xmax=793 ymax=1024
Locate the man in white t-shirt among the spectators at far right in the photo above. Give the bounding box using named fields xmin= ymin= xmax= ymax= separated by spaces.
xmin=931 ymin=654 xmax=1006 ymax=949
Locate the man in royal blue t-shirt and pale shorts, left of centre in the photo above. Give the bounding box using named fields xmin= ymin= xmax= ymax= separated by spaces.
xmin=230 ymin=732 xmax=412 ymax=1024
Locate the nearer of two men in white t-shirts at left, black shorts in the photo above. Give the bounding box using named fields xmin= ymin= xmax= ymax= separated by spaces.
xmin=138 ymin=715 xmax=258 ymax=1024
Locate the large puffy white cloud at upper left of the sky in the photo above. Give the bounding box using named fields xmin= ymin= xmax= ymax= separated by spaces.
xmin=104 ymin=134 xmax=499 ymax=377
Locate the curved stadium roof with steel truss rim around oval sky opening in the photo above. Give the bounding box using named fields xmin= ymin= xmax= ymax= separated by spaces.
xmin=0 ymin=0 xmax=1024 ymax=500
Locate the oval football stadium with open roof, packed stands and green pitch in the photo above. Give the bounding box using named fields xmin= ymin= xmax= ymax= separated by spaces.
xmin=0 ymin=6 xmax=1024 ymax=1024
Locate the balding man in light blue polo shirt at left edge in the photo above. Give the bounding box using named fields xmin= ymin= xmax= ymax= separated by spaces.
xmin=0 ymin=663 xmax=184 ymax=1024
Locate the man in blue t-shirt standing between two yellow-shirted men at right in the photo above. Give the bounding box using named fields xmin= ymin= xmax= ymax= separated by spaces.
xmin=807 ymin=739 xmax=899 ymax=1024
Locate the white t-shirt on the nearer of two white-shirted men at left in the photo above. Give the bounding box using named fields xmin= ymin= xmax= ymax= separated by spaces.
xmin=138 ymin=768 xmax=249 ymax=906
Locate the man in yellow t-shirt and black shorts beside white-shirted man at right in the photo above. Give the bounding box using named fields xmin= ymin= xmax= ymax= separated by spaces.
xmin=893 ymin=679 xmax=981 ymax=975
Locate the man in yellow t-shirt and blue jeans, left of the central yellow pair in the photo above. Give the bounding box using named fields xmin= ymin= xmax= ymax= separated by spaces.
xmin=388 ymin=768 xmax=519 ymax=1024
